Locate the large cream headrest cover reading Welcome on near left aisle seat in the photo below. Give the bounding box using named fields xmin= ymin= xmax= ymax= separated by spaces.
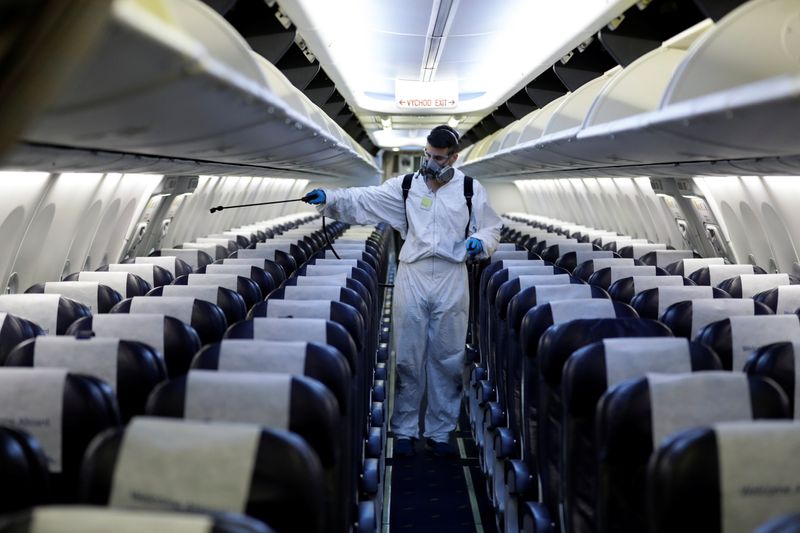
xmin=109 ymin=417 xmax=261 ymax=512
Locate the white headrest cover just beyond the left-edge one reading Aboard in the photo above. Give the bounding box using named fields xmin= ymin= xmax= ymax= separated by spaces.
xmin=33 ymin=336 xmax=119 ymax=391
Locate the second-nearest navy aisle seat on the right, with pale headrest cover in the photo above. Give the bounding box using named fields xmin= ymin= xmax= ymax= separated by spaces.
xmin=592 ymin=370 xmax=788 ymax=533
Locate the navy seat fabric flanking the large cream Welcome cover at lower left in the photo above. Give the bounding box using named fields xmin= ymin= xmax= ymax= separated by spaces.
xmin=80 ymin=417 xmax=326 ymax=533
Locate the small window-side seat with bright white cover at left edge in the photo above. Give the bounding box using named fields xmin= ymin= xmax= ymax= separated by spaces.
xmin=0 ymin=294 xmax=92 ymax=335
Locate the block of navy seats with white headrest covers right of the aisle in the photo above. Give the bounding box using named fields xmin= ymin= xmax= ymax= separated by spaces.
xmin=465 ymin=212 xmax=800 ymax=532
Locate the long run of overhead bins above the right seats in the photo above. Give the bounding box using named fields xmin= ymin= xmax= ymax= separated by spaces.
xmin=461 ymin=0 xmax=800 ymax=177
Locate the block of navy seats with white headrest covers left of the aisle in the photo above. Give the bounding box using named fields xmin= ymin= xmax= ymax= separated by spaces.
xmin=0 ymin=213 xmax=393 ymax=531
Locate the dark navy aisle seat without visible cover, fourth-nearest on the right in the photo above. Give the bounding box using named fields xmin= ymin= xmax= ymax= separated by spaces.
xmin=522 ymin=316 xmax=672 ymax=525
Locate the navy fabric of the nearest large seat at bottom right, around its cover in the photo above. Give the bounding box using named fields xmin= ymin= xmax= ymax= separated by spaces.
xmin=647 ymin=421 xmax=800 ymax=533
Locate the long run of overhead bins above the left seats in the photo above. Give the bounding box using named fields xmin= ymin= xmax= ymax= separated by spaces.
xmin=7 ymin=0 xmax=378 ymax=184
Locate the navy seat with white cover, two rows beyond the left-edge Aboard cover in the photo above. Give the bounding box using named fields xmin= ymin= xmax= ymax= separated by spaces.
xmin=67 ymin=313 xmax=201 ymax=377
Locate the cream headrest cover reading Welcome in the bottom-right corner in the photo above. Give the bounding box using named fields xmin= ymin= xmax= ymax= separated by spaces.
xmin=714 ymin=420 xmax=800 ymax=533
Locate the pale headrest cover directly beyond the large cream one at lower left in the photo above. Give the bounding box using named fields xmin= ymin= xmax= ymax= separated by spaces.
xmin=184 ymin=370 xmax=292 ymax=429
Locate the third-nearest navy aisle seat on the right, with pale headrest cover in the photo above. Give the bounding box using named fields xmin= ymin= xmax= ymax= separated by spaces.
xmin=561 ymin=338 xmax=722 ymax=532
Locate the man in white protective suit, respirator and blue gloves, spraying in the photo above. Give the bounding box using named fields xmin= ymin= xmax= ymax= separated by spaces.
xmin=304 ymin=126 xmax=502 ymax=456
